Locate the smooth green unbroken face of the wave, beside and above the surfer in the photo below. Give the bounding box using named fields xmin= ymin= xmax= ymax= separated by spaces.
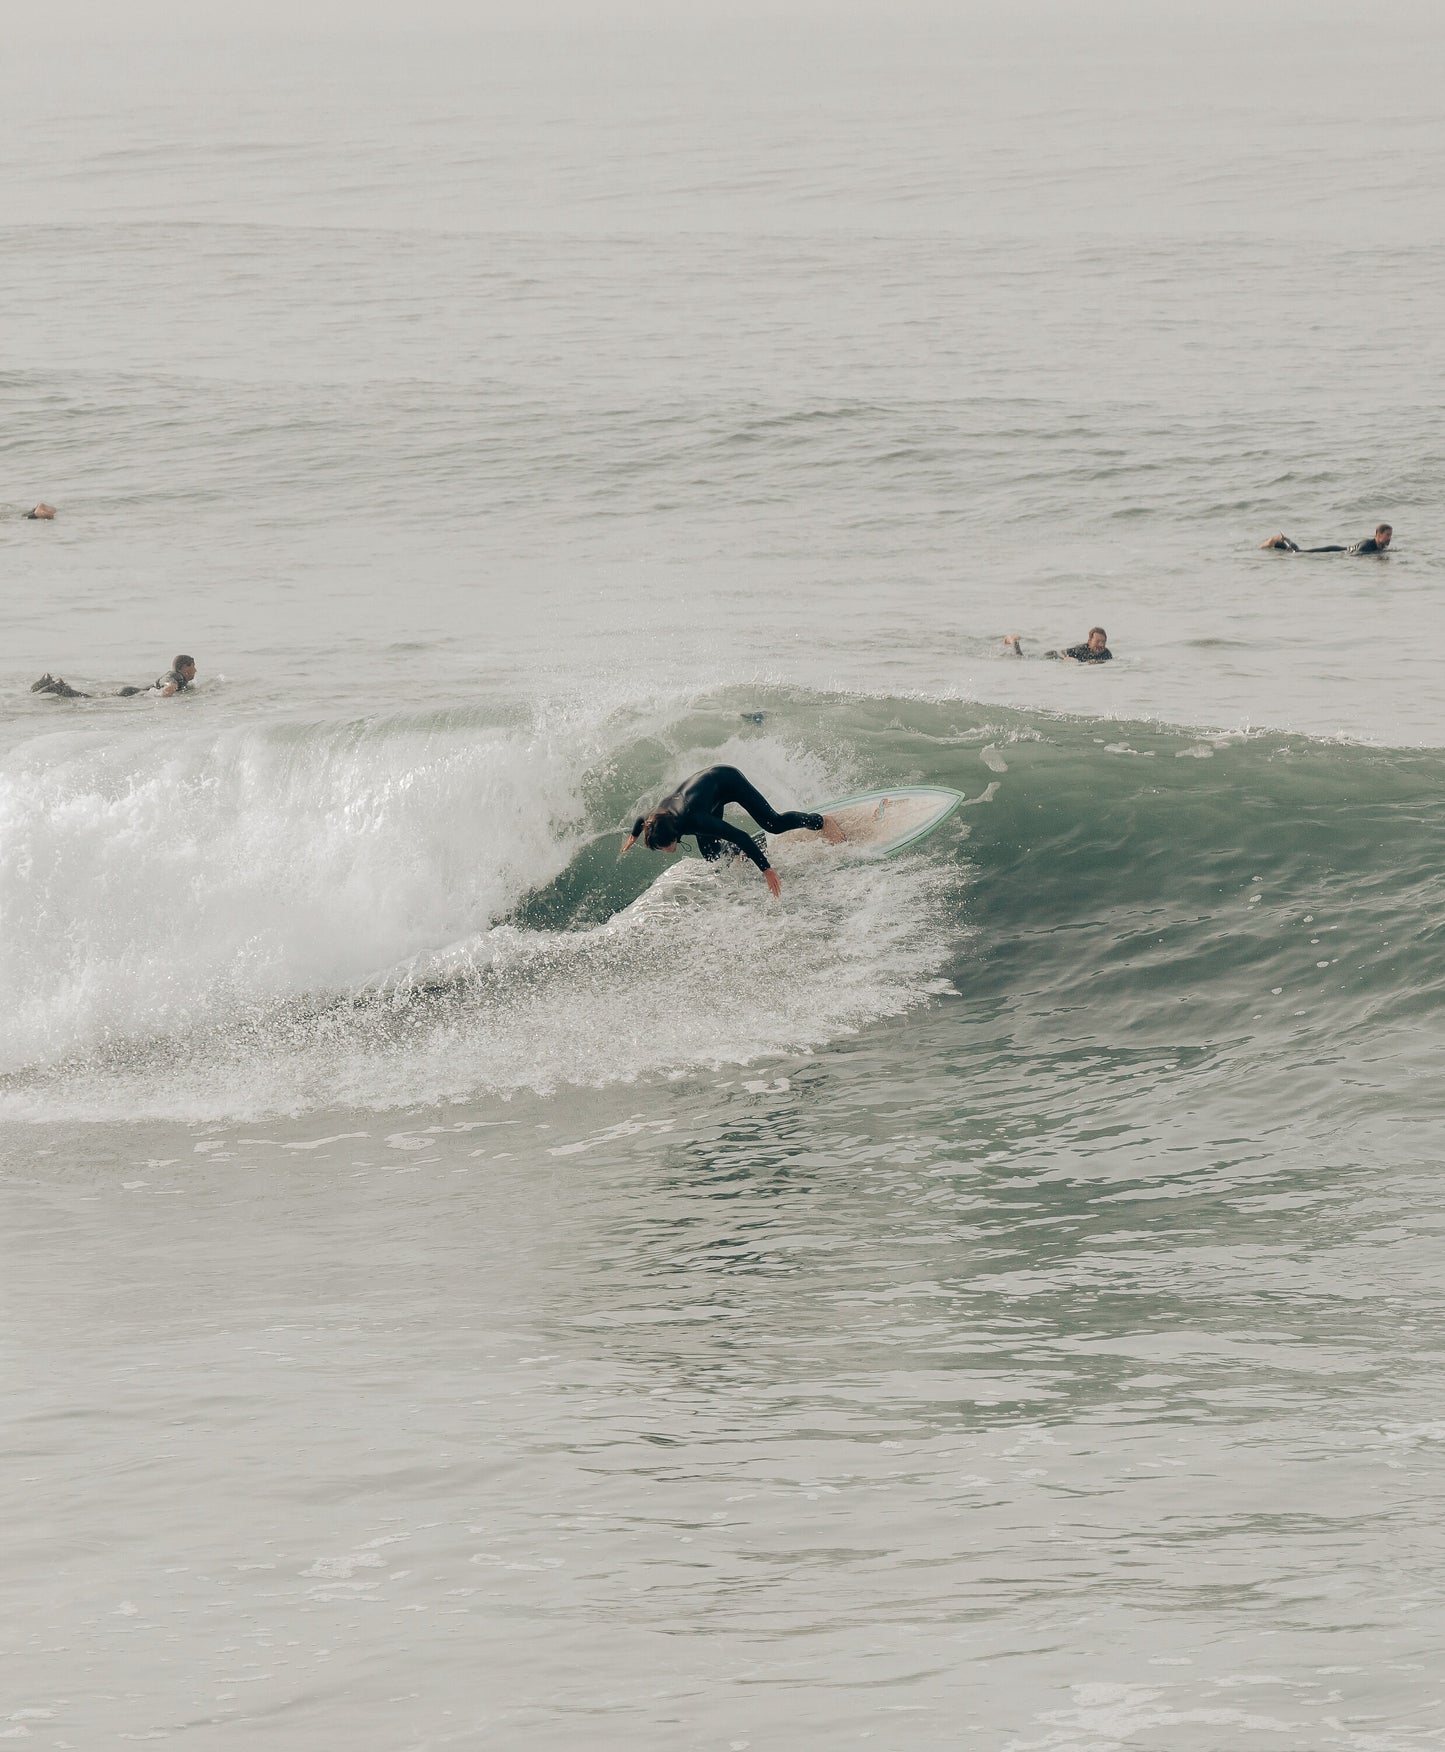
xmin=534 ymin=696 xmax=1445 ymax=1111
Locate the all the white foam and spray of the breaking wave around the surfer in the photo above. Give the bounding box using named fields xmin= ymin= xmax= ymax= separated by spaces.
xmin=0 ymin=700 xmax=960 ymax=1118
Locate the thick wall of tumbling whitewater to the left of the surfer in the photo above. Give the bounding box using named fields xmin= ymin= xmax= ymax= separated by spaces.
xmin=0 ymin=720 xmax=592 ymax=1072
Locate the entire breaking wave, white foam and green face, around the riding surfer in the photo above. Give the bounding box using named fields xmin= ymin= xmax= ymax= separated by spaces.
xmin=0 ymin=692 xmax=1445 ymax=1120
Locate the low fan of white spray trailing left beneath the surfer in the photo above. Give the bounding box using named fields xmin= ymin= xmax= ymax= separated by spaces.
xmin=0 ymin=858 xmax=955 ymax=1120
